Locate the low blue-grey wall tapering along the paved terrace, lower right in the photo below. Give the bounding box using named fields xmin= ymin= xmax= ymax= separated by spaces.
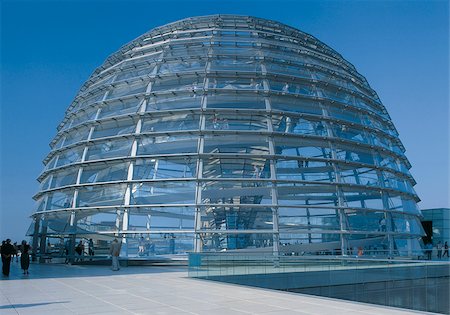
xmin=200 ymin=264 xmax=450 ymax=314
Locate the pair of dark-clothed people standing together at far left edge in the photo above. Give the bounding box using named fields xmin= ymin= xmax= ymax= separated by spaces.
xmin=0 ymin=238 xmax=31 ymax=277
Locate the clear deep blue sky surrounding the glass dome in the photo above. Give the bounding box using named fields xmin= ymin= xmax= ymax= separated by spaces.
xmin=0 ymin=0 xmax=450 ymax=240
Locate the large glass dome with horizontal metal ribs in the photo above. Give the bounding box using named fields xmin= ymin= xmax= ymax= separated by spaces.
xmin=28 ymin=15 xmax=423 ymax=256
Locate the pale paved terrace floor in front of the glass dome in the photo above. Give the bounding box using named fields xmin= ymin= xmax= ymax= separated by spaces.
xmin=0 ymin=263 xmax=436 ymax=315
